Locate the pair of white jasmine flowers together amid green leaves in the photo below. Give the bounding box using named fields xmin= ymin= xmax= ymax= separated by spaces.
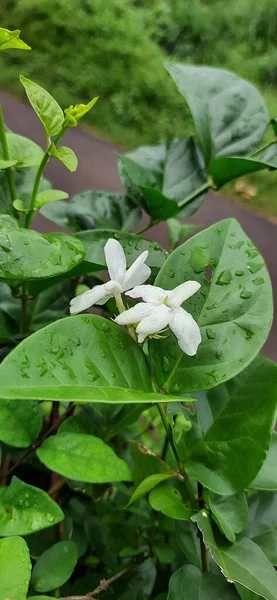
xmin=70 ymin=238 xmax=201 ymax=356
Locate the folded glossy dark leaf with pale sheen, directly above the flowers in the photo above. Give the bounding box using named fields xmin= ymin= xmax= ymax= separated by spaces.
xmin=120 ymin=137 xmax=207 ymax=221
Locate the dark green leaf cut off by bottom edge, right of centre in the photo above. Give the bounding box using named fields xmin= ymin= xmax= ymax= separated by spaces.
xmin=167 ymin=565 xmax=238 ymax=600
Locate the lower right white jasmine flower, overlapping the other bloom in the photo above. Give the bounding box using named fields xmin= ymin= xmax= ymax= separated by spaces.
xmin=115 ymin=281 xmax=201 ymax=356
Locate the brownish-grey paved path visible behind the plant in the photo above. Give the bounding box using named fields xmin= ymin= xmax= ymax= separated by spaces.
xmin=0 ymin=92 xmax=277 ymax=361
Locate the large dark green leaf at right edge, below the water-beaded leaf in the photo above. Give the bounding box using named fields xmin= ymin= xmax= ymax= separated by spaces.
xmin=185 ymin=357 xmax=277 ymax=495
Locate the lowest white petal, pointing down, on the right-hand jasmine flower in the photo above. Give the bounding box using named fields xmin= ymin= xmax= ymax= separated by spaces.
xmin=169 ymin=308 xmax=201 ymax=356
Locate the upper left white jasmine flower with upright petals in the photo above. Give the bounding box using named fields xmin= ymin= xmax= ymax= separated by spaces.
xmin=70 ymin=238 xmax=151 ymax=315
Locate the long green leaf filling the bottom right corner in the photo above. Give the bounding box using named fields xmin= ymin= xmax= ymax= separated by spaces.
xmin=192 ymin=511 xmax=277 ymax=600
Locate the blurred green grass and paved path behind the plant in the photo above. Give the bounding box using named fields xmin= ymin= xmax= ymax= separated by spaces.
xmin=0 ymin=0 xmax=277 ymax=358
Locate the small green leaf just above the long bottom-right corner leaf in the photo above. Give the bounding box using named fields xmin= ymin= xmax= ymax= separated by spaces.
xmin=208 ymin=492 xmax=248 ymax=542
